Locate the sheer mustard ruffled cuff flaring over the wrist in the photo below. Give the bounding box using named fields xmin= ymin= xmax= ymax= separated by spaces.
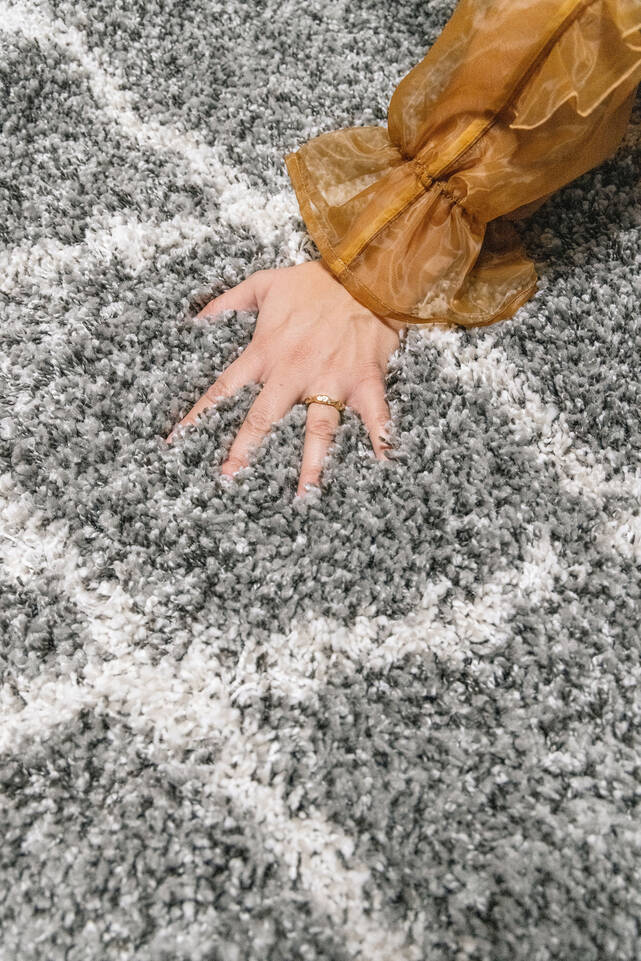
xmin=286 ymin=127 xmax=537 ymax=326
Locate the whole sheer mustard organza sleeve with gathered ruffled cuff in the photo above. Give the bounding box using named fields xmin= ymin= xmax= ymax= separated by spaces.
xmin=285 ymin=0 xmax=641 ymax=327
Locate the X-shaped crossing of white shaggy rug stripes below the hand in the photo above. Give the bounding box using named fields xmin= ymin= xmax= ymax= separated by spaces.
xmin=0 ymin=478 xmax=624 ymax=961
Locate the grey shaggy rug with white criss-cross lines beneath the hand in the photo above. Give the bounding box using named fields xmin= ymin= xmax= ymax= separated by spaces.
xmin=0 ymin=0 xmax=641 ymax=961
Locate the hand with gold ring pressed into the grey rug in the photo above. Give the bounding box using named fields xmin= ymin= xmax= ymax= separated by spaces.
xmin=166 ymin=261 xmax=403 ymax=496
